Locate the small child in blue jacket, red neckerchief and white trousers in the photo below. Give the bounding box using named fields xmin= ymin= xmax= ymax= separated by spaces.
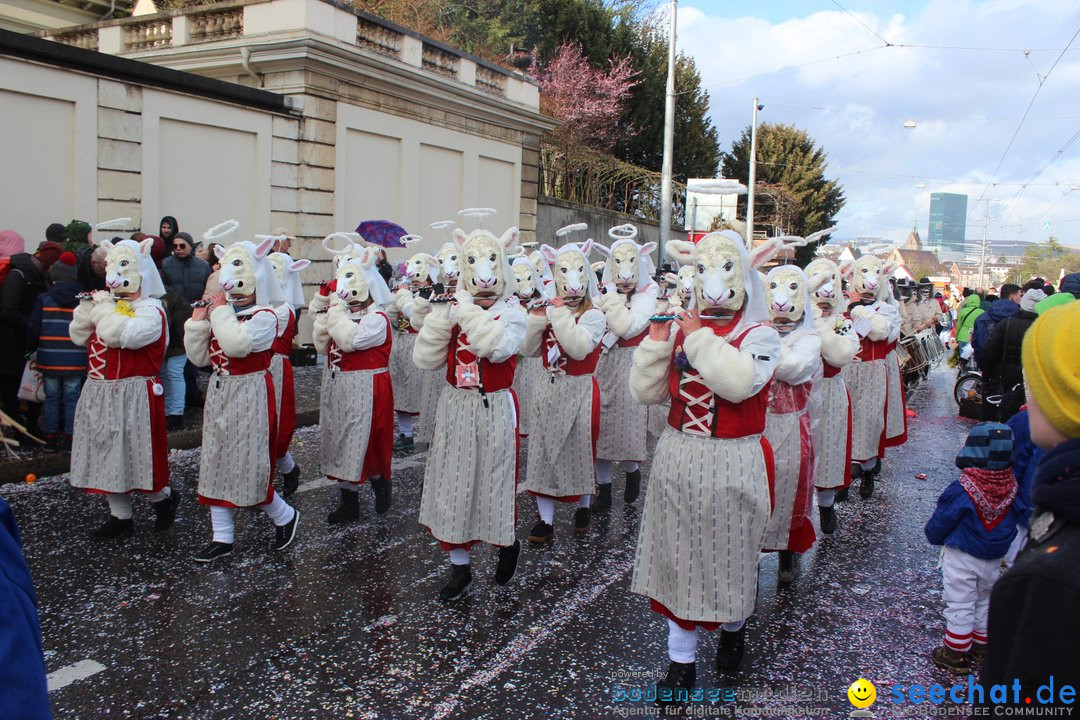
xmin=924 ymin=422 xmax=1027 ymax=675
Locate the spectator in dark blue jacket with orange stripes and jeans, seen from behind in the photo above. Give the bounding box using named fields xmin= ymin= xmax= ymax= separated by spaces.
xmin=26 ymin=252 xmax=86 ymax=452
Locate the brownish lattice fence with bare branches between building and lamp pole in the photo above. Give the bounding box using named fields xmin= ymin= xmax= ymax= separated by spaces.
xmin=540 ymin=142 xmax=686 ymax=226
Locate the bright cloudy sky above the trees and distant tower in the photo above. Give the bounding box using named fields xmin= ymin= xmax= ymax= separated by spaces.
xmin=678 ymin=0 xmax=1080 ymax=245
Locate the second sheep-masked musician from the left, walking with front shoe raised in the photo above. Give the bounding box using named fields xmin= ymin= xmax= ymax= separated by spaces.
xmin=184 ymin=229 xmax=300 ymax=562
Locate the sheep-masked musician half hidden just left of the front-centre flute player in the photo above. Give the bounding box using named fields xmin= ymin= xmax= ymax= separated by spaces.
xmin=387 ymin=248 xmax=443 ymax=452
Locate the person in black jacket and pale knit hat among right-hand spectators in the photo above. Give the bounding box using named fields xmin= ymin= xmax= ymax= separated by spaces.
xmin=978 ymin=287 xmax=1047 ymax=422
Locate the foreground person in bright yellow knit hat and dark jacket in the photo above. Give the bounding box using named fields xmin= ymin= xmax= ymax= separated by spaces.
xmin=981 ymin=302 xmax=1080 ymax=707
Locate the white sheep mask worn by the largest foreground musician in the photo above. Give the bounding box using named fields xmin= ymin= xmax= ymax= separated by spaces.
xmin=667 ymin=230 xmax=781 ymax=323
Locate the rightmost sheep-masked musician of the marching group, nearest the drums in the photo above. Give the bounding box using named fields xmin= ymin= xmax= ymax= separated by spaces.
xmin=840 ymin=255 xmax=906 ymax=500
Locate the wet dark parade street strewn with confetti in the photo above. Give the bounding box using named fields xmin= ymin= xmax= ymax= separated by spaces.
xmin=0 ymin=366 xmax=968 ymax=720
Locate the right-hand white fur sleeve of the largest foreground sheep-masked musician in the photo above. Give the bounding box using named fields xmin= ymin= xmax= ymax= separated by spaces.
xmin=683 ymin=325 xmax=780 ymax=403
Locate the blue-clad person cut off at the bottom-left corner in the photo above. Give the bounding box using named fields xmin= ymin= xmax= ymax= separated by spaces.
xmin=0 ymin=499 xmax=52 ymax=720
